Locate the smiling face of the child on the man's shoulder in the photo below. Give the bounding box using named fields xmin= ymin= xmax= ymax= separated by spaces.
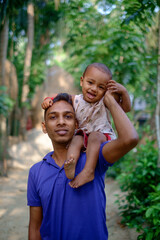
xmin=80 ymin=67 xmax=110 ymax=103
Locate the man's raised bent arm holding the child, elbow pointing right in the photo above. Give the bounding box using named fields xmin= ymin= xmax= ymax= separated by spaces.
xmin=102 ymin=91 xmax=138 ymax=163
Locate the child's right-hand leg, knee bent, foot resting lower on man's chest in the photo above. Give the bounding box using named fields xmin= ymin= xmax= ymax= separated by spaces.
xmin=69 ymin=132 xmax=106 ymax=188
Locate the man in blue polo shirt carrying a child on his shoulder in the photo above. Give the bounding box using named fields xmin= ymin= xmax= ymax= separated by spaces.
xmin=27 ymin=91 xmax=138 ymax=240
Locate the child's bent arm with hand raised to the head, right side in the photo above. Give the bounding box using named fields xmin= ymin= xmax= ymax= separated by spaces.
xmin=107 ymin=80 xmax=131 ymax=112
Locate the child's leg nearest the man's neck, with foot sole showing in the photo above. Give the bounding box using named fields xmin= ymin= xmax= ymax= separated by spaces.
xmin=64 ymin=135 xmax=84 ymax=179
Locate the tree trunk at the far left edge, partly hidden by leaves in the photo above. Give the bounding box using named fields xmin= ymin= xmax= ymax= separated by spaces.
xmin=0 ymin=17 xmax=9 ymax=175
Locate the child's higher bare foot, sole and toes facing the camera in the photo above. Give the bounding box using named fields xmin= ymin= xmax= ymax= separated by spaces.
xmin=64 ymin=156 xmax=76 ymax=179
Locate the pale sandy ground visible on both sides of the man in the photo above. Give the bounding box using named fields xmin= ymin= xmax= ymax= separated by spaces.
xmin=0 ymin=130 xmax=138 ymax=240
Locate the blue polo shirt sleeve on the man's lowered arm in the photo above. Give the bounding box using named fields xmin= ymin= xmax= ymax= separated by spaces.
xmin=27 ymin=169 xmax=41 ymax=207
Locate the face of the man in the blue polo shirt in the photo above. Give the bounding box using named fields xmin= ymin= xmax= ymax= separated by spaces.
xmin=42 ymin=101 xmax=76 ymax=144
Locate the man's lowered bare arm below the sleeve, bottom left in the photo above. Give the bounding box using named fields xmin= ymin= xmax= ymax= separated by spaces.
xmin=28 ymin=207 xmax=43 ymax=240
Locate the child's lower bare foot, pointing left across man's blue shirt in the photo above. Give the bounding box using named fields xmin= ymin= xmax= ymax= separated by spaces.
xmin=69 ymin=169 xmax=94 ymax=188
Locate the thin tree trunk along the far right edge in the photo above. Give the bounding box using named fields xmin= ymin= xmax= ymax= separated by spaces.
xmin=156 ymin=10 xmax=160 ymax=167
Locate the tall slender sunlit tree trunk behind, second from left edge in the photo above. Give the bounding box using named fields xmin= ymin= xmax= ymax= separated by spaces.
xmin=21 ymin=3 xmax=34 ymax=140
